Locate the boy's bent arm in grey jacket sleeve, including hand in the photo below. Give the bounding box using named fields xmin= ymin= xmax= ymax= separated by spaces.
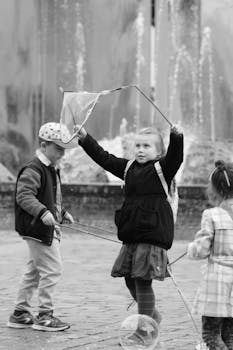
xmin=16 ymin=167 xmax=55 ymax=225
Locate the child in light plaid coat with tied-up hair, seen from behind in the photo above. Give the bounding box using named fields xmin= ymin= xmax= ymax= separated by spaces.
xmin=188 ymin=161 xmax=233 ymax=350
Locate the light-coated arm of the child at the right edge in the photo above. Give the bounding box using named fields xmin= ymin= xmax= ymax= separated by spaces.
xmin=188 ymin=209 xmax=214 ymax=259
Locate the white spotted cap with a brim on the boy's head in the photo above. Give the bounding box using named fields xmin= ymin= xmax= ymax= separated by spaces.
xmin=39 ymin=122 xmax=78 ymax=148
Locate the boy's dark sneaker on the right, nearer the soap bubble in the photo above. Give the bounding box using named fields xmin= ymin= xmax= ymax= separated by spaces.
xmin=32 ymin=313 xmax=70 ymax=332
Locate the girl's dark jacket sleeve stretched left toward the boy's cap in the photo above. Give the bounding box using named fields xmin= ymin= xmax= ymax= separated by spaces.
xmin=79 ymin=134 xmax=128 ymax=180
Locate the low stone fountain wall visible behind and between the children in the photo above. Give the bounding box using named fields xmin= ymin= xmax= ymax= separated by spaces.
xmin=0 ymin=183 xmax=208 ymax=240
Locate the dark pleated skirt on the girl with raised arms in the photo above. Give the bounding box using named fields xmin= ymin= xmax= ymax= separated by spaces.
xmin=111 ymin=243 xmax=169 ymax=281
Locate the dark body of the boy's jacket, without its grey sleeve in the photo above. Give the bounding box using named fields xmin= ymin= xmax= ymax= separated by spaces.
xmin=15 ymin=157 xmax=65 ymax=245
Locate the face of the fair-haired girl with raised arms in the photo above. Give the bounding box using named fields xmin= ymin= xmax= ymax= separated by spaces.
xmin=134 ymin=134 xmax=161 ymax=164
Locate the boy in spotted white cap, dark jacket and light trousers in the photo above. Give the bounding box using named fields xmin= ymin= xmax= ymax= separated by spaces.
xmin=7 ymin=122 xmax=75 ymax=331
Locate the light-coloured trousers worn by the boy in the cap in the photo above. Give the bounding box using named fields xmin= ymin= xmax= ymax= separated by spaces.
xmin=15 ymin=239 xmax=62 ymax=313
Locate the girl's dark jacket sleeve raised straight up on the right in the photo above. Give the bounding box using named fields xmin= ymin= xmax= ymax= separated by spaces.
xmin=160 ymin=132 xmax=184 ymax=185
